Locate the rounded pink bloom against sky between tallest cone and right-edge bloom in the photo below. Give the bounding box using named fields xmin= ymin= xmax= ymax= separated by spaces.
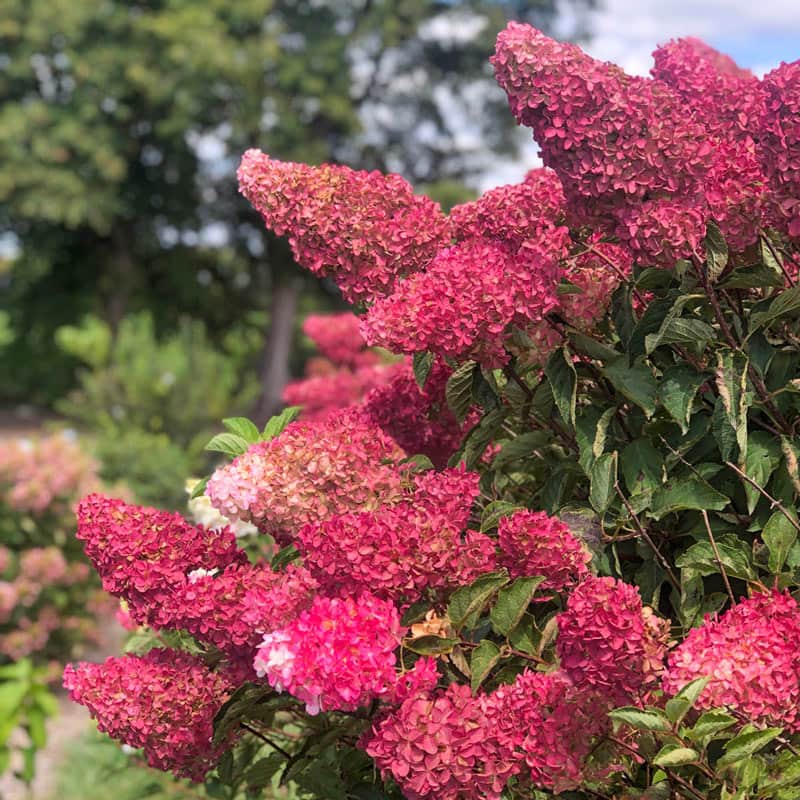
xmin=650 ymin=36 xmax=764 ymax=140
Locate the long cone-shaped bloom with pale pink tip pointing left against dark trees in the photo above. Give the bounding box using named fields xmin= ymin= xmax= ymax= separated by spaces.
xmin=238 ymin=150 xmax=449 ymax=303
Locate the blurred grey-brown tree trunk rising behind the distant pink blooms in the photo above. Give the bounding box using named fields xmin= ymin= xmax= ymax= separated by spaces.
xmin=254 ymin=276 xmax=300 ymax=426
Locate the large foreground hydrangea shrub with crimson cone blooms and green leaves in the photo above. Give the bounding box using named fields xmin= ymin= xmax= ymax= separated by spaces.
xmin=65 ymin=23 xmax=800 ymax=800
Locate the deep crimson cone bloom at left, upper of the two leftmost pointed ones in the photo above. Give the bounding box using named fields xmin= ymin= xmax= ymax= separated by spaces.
xmin=77 ymin=494 xmax=247 ymax=622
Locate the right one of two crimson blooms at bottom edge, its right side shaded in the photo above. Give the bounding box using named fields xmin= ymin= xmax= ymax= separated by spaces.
xmin=485 ymin=671 xmax=611 ymax=794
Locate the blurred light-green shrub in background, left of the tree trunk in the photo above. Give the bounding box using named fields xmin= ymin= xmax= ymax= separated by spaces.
xmin=56 ymin=312 xmax=257 ymax=506
